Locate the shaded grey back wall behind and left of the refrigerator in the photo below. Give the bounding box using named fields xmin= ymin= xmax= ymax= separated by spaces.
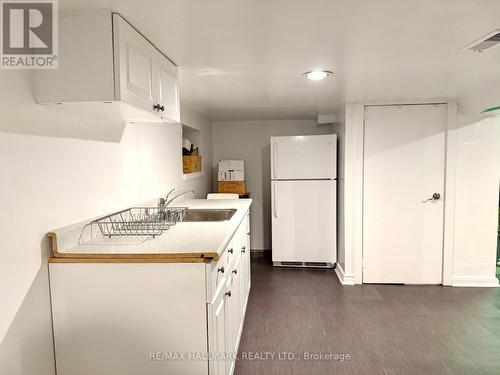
xmin=213 ymin=120 xmax=331 ymax=250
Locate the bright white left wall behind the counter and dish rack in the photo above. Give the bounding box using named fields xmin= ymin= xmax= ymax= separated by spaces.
xmin=0 ymin=71 xmax=210 ymax=375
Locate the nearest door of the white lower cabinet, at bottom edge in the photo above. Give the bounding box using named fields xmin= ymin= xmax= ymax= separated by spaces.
xmin=208 ymin=287 xmax=228 ymax=375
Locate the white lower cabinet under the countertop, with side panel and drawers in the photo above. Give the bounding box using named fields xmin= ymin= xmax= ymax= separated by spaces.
xmin=49 ymin=213 xmax=250 ymax=375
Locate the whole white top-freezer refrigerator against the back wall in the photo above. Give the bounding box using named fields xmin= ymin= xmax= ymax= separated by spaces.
xmin=271 ymin=134 xmax=337 ymax=267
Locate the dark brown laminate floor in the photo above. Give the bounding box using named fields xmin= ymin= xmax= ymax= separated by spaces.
xmin=235 ymin=256 xmax=500 ymax=375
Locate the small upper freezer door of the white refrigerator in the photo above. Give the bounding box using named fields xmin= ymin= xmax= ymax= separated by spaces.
xmin=271 ymin=134 xmax=337 ymax=180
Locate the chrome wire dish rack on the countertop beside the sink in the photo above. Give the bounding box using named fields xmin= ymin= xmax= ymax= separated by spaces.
xmin=82 ymin=207 xmax=187 ymax=238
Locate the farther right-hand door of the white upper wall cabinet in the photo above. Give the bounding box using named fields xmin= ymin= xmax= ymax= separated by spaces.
xmin=155 ymin=52 xmax=180 ymax=122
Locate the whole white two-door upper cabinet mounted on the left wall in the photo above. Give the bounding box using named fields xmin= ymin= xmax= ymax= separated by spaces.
xmin=35 ymin=13 xmax=180 ymax=122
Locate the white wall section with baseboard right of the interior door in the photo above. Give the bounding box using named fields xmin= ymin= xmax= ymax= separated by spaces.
xmin=451 ymin=115 xmax=500 ymax=286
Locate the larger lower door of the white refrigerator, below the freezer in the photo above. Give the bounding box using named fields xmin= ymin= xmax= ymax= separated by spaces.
xmin=271 ymin=180 xmax=337 ymax=263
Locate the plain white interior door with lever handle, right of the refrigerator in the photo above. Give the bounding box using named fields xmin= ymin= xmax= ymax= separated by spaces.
xmin=363 ymin=104 xmax=447 ymax=284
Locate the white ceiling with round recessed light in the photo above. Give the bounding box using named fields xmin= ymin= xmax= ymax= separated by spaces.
xmin=59 ymin=0 xmax=500 ymax=120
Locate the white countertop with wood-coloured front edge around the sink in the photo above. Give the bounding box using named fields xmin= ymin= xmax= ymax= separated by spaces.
xmin=49 ymin=199 xmax=252 ymax=259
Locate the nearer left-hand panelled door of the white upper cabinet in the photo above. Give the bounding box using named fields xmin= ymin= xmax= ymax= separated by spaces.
xmin=113 ymin=14 xmax=157 ymax=112
